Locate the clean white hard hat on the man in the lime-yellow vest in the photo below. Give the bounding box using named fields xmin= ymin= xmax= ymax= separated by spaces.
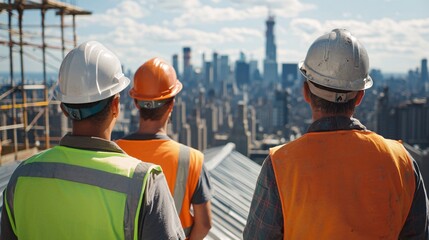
xmin=55 ymin=41 xmax=130 ymax=104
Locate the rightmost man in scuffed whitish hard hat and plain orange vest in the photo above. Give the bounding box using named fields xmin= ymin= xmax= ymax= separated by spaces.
xmin=243 ymin=29 xmax=428 ymax=240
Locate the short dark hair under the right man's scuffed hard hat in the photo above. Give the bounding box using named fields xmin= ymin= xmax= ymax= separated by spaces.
xmin=308 ymin=82 xmax=356 ymax=114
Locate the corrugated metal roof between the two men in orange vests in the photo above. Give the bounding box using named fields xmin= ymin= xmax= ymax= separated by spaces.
xmin=204 ymin=143 xmax=261 ymax=240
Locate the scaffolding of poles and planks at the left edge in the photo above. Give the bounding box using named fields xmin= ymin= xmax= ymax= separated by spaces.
xmin=0 ymin=0 xmax=91 ymax=164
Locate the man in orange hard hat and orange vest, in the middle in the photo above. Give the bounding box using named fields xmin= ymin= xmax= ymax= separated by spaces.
xmin=116 ymin=58 xmax=211 ymax=239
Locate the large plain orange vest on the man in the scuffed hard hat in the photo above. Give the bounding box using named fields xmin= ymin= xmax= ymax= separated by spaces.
xmin=270 ymin=130 xmax=415 ymax=240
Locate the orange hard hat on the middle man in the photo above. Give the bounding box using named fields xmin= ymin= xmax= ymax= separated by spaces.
xmin=130 ymin=58 xmax=183 ymax=101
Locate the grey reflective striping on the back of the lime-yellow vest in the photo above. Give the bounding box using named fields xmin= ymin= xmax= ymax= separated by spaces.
xmin=3 ymin=162 xmax=151 ymax=240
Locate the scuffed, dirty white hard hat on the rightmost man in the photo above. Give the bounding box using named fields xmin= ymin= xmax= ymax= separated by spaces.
xmin=299 ymin=29 xmax=373 ymax=91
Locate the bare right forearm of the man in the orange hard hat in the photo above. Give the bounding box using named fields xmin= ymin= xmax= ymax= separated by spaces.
xmin=189 ymin=201 xmax=212 ymax=240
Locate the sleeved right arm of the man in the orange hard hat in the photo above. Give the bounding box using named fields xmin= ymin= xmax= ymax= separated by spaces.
xmin=189 ymin=165 xmax=212 ymax=240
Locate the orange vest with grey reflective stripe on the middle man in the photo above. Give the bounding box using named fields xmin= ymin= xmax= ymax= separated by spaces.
xmin=116 ymin=135 xmax=204 ymax=236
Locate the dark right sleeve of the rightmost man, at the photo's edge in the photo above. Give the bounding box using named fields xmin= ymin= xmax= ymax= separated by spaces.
xmin=399 ymin=156 xmax=429 ymax=240
